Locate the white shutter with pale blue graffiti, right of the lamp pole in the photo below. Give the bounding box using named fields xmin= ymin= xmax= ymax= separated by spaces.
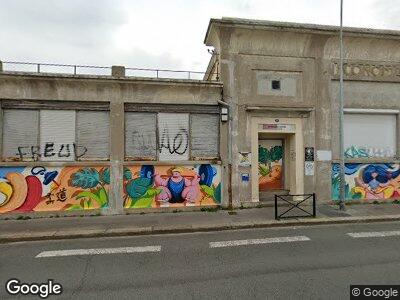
xmin=343 ymin=114 xmax=396 ymax=158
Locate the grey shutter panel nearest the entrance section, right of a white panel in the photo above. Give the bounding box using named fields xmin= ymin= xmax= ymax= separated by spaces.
xmin=190 ymin=114 xmax=219 ymax=158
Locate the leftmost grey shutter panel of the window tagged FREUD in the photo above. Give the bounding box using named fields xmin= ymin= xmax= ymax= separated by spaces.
xmin=3 ymin=109 xmax=39 ymax=160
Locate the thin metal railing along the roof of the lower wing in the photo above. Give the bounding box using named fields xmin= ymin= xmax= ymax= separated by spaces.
xmin=2 ymin=61 xmax=219 ymax=80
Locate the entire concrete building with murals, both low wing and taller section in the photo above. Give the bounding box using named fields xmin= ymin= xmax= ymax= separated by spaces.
xmin=0 ymin=18 xmax=400 ymax=216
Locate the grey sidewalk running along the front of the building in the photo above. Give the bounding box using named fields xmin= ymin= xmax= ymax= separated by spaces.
xmin=0 ymin=204 xmax=400 ymax=243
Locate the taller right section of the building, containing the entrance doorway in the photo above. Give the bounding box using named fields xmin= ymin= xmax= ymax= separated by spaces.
xmin=205 ymin=18 xmax=400 ymax=206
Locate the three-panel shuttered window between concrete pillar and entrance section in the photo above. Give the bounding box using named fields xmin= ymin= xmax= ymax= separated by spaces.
xmin=125 ymin=109 xmax=219 ymax=161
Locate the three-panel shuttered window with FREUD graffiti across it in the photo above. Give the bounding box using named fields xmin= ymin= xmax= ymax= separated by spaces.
xmin=3 ymin=109 xmax=110 ymax=161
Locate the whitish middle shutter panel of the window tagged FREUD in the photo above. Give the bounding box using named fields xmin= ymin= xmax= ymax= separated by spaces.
xmin=40 ymin=110 xmax=75 ymax=161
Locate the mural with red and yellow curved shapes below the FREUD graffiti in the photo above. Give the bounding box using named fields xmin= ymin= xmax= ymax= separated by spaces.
xmin=0 ymin=166 xmax=110 ymax=213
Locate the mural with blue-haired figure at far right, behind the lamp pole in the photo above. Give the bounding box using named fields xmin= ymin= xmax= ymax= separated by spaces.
xmin=332 ymin=163 xmax=400 ymax=200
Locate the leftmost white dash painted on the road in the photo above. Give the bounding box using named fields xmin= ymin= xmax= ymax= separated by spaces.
xmin=36 ymin=246 xmax=161 ymax=258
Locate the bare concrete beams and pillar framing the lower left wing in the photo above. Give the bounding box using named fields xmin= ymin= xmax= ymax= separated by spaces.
xmin=0 ymin=70 xmax=228 ymax=214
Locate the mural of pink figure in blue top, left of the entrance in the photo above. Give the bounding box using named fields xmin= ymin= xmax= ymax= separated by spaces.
xmin=124 ymin=164 xmax=221 ymax=208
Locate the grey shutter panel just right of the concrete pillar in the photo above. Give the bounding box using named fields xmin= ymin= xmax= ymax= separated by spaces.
xmin=125 ymin=112 xmax=157 ymax=160
